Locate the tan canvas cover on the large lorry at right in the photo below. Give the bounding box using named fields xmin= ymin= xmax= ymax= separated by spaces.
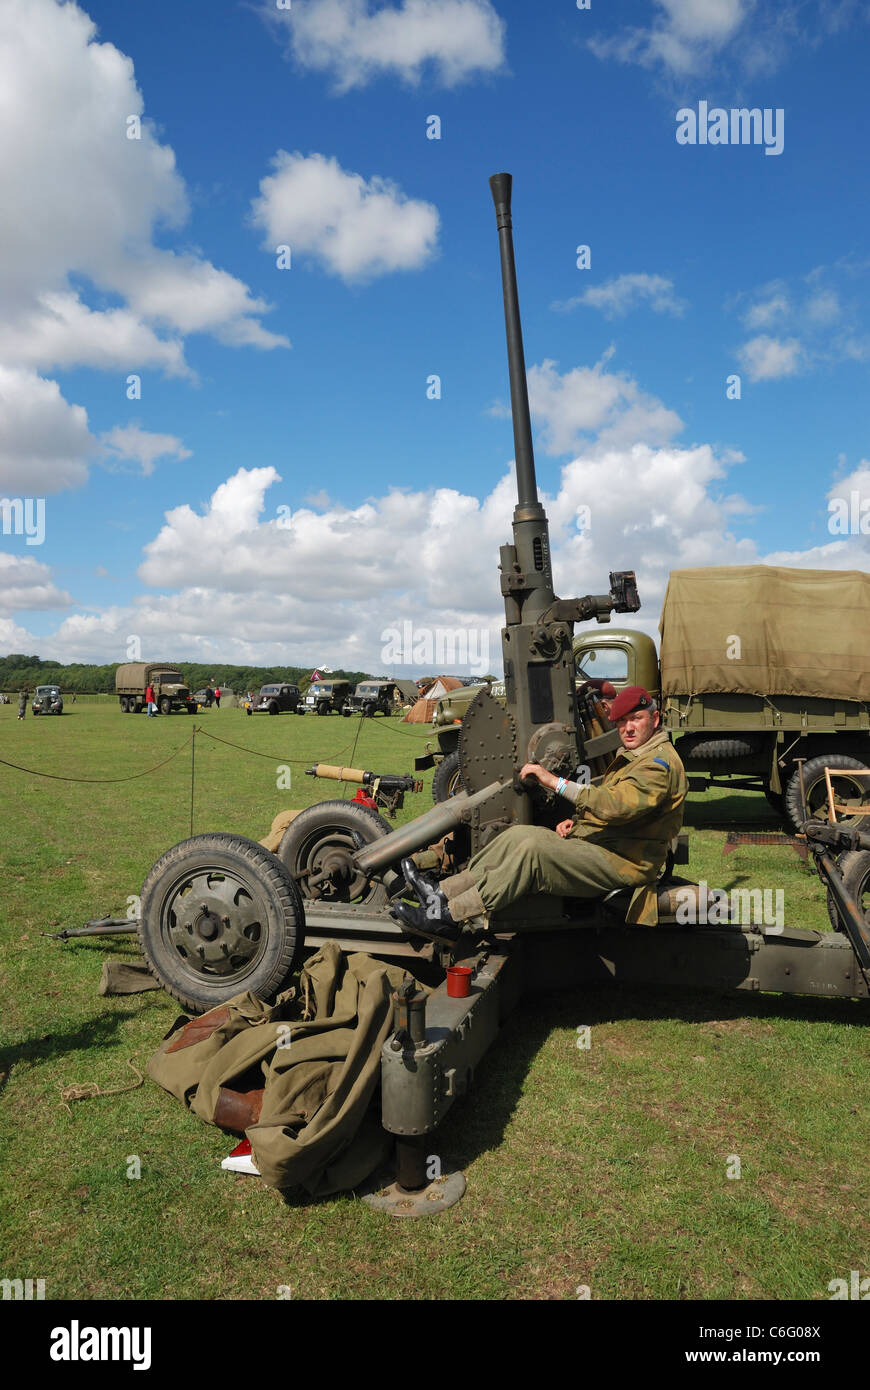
xmin=659 ymin=564 xmax=870 ymax=701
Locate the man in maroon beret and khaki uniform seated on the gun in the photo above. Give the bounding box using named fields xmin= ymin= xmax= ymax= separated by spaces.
xmin=391 ymin=685 xmax=688 ymax=942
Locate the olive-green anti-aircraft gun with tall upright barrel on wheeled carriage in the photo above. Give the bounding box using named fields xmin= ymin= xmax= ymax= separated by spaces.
xmin=139 ymin=174 xmax=869 ymax=1213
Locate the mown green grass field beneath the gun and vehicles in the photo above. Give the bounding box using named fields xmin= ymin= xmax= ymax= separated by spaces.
xmin=0 ymin=701 xmax=870 ymax=1300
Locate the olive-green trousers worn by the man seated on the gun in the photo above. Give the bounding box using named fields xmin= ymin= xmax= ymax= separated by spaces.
xmin=441 ymin=826 xmax=649 ymax=922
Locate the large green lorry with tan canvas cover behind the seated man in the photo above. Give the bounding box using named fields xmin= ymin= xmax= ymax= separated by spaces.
xmin=574 ymin=564 xmax=870 ymax=830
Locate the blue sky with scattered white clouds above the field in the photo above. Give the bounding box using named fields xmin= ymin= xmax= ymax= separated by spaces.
xmin=0 ymin=0 xmax=870 ymax=674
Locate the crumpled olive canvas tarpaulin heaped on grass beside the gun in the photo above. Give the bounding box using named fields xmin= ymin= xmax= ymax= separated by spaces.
xmin=147 ymin=941 xmax=404 ymax=1195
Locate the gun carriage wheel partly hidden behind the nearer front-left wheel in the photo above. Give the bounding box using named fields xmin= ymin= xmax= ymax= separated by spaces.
xmin=278 ymin=801 xmax=404 ymax=908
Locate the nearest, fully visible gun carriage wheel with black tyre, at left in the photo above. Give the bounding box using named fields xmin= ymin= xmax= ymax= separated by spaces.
xmin=139 ymin=833 xmax=304 ymax=1013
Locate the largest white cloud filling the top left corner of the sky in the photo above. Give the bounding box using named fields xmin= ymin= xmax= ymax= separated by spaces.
xmin=0 ymin=0 xmax=286 ymax=374
